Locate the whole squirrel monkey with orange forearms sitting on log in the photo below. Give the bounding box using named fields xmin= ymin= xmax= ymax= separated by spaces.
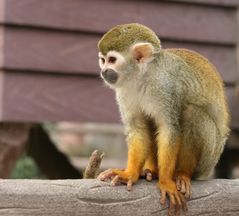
xmin=98 ymin=23 xmax=229 ymax=215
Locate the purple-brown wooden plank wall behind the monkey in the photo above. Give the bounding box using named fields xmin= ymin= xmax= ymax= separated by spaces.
xmin=0 ymin=0 xmax=239 ymax=127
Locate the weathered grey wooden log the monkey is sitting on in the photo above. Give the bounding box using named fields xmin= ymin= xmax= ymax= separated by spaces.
xmin=0 ymin=180 xmax=239 ymax=216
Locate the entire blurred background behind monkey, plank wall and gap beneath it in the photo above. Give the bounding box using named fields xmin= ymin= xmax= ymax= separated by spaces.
xmin=0 ymin=0 xmax=239 ymax=179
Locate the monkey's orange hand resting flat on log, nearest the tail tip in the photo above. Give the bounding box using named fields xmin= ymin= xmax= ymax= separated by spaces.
xmin=97 ymin=169 xmax=139 ymax=191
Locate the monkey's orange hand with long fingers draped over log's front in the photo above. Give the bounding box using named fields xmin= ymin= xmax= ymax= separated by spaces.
xmin=159 ymin=180 xmax=187 ymax=216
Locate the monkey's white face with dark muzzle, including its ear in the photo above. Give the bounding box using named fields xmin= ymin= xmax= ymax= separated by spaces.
xmin=99 ymin=43 xmax=154 ymax=88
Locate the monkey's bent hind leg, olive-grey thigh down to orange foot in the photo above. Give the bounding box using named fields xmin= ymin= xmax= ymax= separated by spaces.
xmin=175 ymin=105 xmax=217 ymax=198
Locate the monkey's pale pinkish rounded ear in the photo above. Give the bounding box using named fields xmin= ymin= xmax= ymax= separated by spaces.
xmin=131 ymin=43 xmax=154 ymax=63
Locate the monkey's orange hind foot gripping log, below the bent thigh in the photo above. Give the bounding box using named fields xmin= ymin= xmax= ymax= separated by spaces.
xmin=176 ymin=172 xmax=192 ymax=199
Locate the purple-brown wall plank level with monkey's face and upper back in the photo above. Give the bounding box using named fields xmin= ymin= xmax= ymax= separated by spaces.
xmin=0 ymin=27 xmax=238 ymax=83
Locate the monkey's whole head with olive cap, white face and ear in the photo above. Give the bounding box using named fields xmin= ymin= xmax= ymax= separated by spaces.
xmin=98 ymin=23 xmax=161 ymax=88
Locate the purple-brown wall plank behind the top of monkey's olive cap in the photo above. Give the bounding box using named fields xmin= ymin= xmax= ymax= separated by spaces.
xmin=0 ymin=0 xmax=236 ymax=44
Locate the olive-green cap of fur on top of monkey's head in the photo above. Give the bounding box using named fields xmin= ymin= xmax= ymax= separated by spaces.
xmin=98 ymin=23 xmax=160 ymax=55
